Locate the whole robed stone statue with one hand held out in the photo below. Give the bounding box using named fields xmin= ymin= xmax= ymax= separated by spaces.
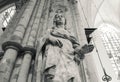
xmin=40 ymin=12 xmax=94 ymax=82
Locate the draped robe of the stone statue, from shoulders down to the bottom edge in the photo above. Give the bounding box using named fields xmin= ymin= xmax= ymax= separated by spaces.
xmin=41 ymin=28 xmax=81 ymax=82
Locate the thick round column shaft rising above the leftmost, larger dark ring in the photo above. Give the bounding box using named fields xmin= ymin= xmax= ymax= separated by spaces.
xmin=11 ymin=0 xmax=37 ymax=43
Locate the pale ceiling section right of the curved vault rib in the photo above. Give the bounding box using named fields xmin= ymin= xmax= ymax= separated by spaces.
xmin=94 ymin=0 xmax=120 ymax=27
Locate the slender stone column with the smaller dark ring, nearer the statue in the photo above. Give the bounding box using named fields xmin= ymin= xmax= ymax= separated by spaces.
xmin=18 ymin=0 xmax=45 ymax=82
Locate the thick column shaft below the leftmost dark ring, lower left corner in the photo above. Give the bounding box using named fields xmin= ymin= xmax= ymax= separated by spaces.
xmin=0 ymin=49 xmax=18 ymax=82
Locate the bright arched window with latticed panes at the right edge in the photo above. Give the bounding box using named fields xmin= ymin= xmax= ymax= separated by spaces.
xmin=98 ymin=24 xmax=120 ymax=75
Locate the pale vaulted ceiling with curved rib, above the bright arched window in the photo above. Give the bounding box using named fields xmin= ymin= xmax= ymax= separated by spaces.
xmin=79 ymin=0 xmax=120 ymax=27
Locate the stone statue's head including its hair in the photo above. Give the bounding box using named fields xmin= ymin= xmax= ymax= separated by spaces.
xmin=53 ymin=13 xmax=66 ymax=26
